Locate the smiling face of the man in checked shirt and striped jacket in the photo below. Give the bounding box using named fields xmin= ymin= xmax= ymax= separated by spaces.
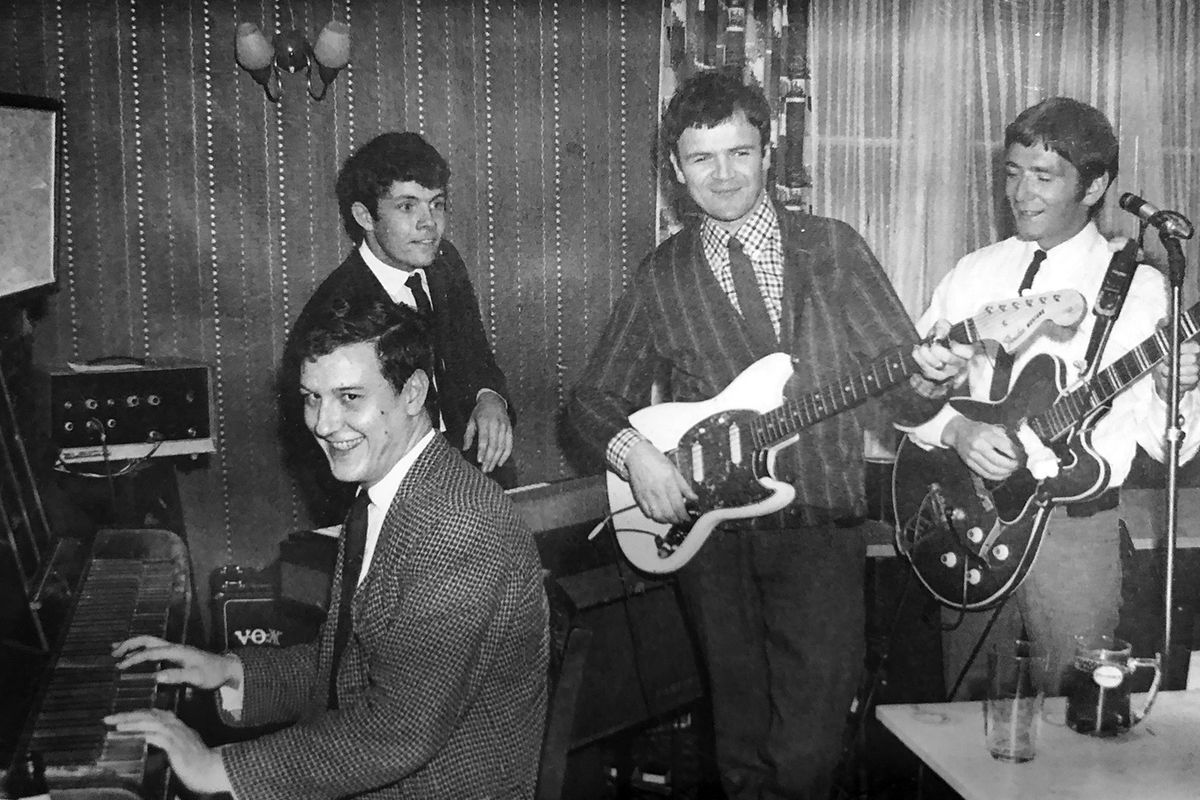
xmin=671 ymin=110 xmax=770 ymax=231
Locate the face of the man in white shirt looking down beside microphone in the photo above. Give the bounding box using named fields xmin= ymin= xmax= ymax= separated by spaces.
xmin=1004 ymin=143 xmax=1108 ymax=249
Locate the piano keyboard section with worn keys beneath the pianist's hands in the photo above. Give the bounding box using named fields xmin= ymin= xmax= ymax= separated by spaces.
xmin=1 ymin=529 xmax=192 ymax=800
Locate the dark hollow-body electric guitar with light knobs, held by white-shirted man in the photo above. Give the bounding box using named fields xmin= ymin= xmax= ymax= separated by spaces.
xmin=892 ymin=298 xmax=1200 ymax=610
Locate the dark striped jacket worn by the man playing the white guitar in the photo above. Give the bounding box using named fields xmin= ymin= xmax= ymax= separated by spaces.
xmin=568 ymin=206 xmax=938 ymax=524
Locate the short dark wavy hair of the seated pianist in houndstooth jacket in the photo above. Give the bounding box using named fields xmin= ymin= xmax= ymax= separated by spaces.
xmin=288 ymin=295 xmax=437 ymax=420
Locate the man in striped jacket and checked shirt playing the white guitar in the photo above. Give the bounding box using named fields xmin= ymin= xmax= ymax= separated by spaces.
xmin=569 ymin=73 xmax=970 ymax=800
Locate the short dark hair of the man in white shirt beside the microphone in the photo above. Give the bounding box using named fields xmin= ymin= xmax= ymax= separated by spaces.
xmin=1004 ymin=97 xmax=1121 ymax=215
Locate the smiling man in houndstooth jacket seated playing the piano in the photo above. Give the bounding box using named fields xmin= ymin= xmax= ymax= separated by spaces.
xmin=106 ymin=297 xmax=548 ymax=800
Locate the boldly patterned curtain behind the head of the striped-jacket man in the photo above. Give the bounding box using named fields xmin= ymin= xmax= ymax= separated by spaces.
xmin=658 ymin=0 xmax=812 ymax=242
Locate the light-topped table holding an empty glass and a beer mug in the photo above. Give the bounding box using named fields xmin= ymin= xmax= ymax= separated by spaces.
xmin=876 ymin=691 xmax=1200 ymax=800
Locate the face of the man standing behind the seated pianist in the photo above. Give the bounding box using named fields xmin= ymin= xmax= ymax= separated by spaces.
xmin=352 ymin=181 xmax=446 ymax=271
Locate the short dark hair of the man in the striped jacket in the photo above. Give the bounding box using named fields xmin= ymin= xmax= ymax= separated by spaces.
xmin=659 ymin=70 xmax=770 ymax=158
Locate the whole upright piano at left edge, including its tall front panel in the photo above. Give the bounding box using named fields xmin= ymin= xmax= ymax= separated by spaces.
xmin=0 ymin=365 xmax=194 ymax=800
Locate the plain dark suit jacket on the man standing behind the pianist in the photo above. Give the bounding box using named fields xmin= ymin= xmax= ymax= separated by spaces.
xmin=298 ymin=240 xmax=515 ymax=450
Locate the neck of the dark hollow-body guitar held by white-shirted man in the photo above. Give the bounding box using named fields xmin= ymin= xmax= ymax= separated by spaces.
xmin=1030 ymin=302 xmax=1200 ymax=441
